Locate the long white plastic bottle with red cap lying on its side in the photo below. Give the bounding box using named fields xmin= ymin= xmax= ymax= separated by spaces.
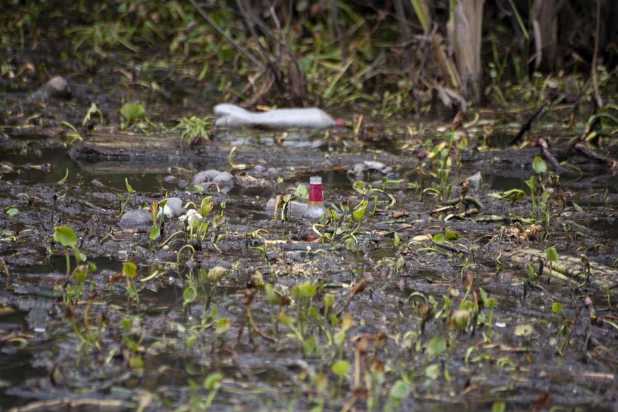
xmin=215 ymin=103 xmax=344 ymax=129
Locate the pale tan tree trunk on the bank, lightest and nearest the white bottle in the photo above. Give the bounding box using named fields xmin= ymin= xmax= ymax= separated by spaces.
xmin=454 ymin=0 xmax=485 ymax=103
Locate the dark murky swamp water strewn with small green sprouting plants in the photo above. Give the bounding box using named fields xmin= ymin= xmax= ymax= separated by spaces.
xmin=0 ymin=84 xmax=618 ymax=410
